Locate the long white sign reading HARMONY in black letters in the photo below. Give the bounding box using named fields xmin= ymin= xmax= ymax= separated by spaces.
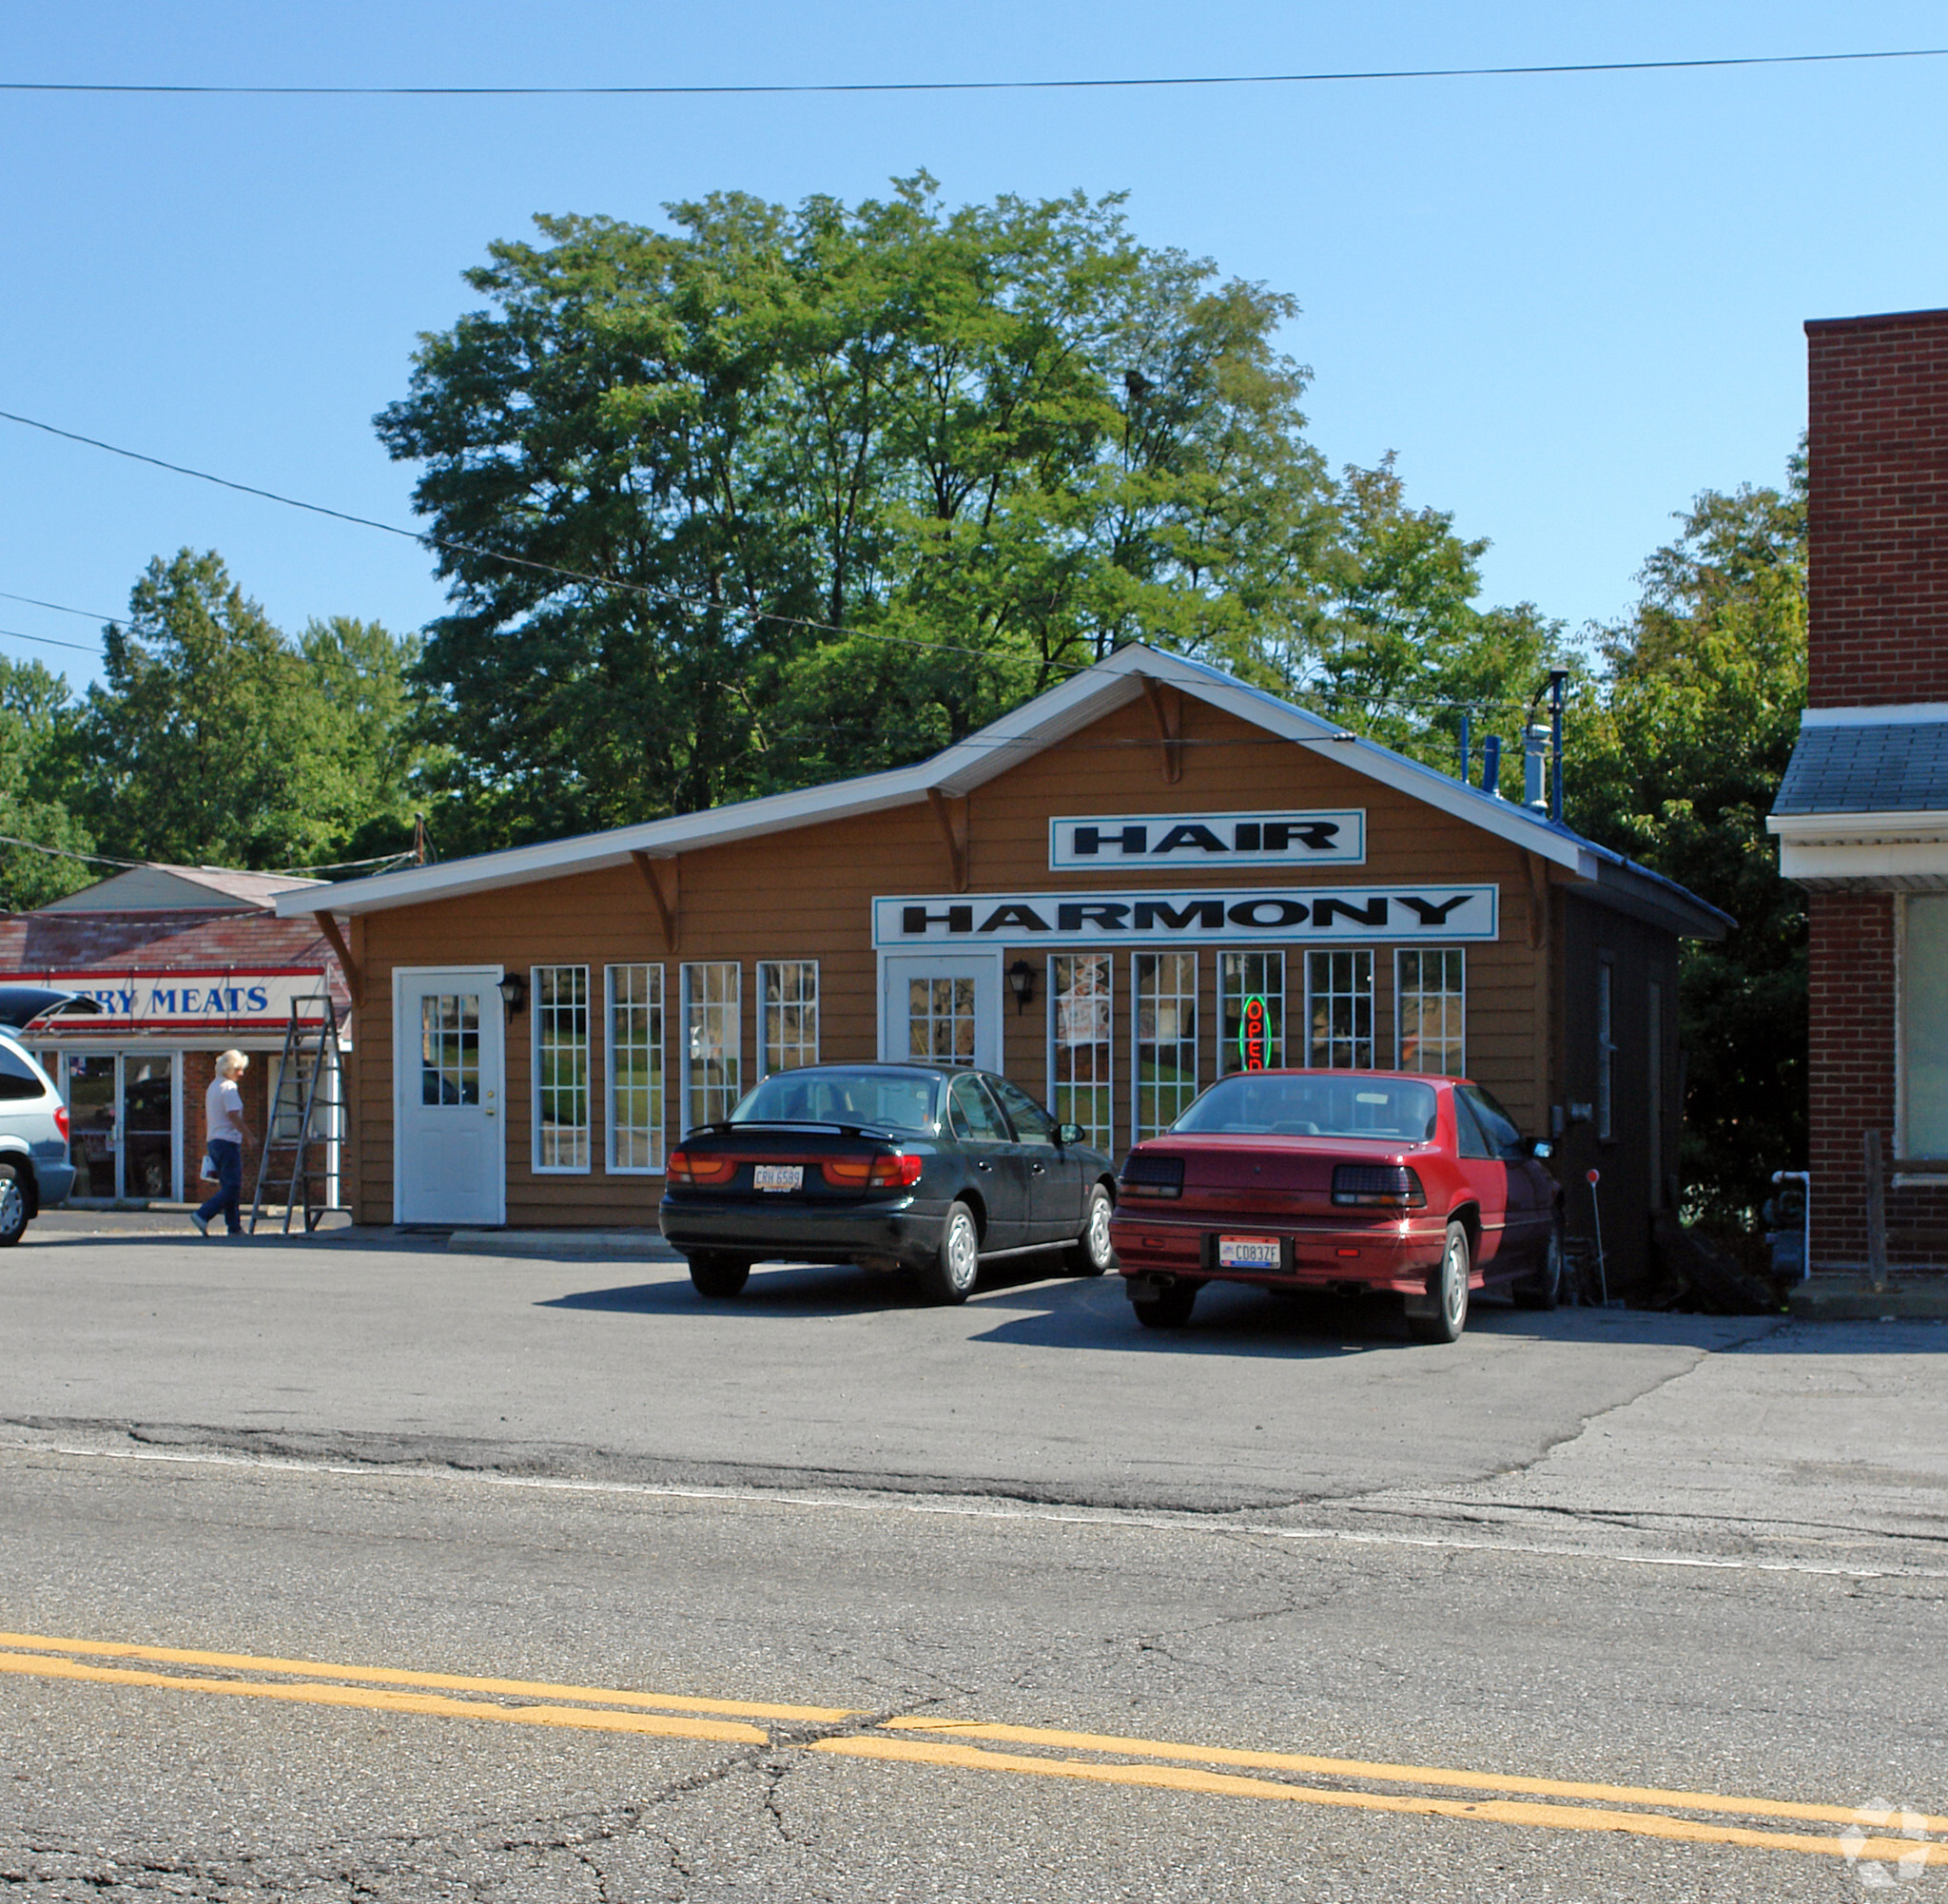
xmin=873 ymin=885 xmax=1500 ymax=952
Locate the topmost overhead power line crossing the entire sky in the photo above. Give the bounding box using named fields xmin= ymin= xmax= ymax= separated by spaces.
xmin=0 ymin=47 xmax=1948 ymax=99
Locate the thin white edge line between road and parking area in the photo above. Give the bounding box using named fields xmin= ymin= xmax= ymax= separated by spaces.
xmin=0 ymin=1441 xmax=1948 ymax=1581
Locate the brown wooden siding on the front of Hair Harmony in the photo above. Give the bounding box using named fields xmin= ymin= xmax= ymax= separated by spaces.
xmin=349 ymin=690 xmax=1550 ymax=1227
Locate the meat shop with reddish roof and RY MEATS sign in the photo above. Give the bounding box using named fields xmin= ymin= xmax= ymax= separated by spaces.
xmin=0 ymin=866 xmax=351 ymax=1201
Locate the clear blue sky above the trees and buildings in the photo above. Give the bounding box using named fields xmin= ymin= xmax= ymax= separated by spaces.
xmin=0 ymin=0 xmax=1948 ymax=684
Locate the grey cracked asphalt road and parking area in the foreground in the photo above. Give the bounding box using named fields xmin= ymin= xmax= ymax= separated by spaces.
xmin=0 ymin=1233 xmax=1948 ymax=1900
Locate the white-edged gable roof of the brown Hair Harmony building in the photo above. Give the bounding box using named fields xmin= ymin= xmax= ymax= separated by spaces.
xmin=277 ymin=643 xmax=1732 ymax=939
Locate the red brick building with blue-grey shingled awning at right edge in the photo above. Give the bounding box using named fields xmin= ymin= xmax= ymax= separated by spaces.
xmin=1769 ymin=312 xmax=1948 ymax=1272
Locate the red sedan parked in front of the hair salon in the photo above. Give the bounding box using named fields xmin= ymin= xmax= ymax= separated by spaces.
xmin=1110 ymin=1071 xmax=1562 ymax=1341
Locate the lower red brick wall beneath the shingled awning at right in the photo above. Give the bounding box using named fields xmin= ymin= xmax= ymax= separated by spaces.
xmin=1808 ymin=892 xmax=1948 ymax=1270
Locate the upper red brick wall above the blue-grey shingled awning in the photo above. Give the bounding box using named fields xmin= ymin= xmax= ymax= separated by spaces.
xmin=1805 ymin=312 xmax=1948 ymax=705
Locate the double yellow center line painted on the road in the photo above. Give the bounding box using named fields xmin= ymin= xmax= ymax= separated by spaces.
xmin=0 ymin=1633 xmax=1948 ymax=1871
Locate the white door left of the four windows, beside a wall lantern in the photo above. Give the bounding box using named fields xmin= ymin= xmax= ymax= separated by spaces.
xmin=394 ymin=965 xmax=506 ymax=1223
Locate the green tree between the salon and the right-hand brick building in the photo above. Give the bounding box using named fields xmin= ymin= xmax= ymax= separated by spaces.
xmin=1568 ymin=456 xmax=1805 ymax=1227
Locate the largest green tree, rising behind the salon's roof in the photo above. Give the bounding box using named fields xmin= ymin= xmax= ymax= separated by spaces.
xmin=378 ymin=175 xmax=1333 ymax=843
